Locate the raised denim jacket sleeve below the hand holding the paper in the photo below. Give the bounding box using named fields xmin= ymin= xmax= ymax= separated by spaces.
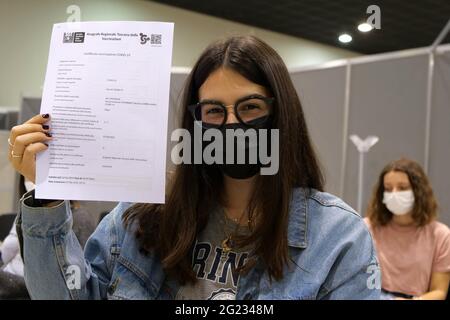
xmin=16 ymin=194 xmax=126 ymax=299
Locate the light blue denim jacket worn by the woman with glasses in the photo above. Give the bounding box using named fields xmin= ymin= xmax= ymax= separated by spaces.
xmin=16 ymin=188 xmax=380 ymax=299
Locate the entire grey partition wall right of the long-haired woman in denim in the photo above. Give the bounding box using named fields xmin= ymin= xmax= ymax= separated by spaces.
xmin=292 ymin=45 xmax=450 ymax=225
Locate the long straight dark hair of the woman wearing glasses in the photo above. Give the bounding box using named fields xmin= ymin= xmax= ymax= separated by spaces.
xmin=124 ymin=36 xmax=323 ymax=284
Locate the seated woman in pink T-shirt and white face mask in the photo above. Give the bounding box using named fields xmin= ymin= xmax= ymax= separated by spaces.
xmin=365 ymin=159 xmax=450 ymax=300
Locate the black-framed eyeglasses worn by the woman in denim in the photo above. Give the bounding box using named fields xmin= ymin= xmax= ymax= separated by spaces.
xmin=188 ymin=94 xmax=275 ymax=127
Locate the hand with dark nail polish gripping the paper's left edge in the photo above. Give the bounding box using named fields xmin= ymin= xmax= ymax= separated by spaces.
xmin=8 ymin=114 xmax=52 ymax=183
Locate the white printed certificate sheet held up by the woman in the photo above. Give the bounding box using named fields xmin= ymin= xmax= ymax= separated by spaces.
xmin=36 ymin=22 xmax=173 ymax=203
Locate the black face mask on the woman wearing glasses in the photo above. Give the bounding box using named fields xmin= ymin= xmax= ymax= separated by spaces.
xmin=203 ymin=117 xmax=271 ymax=179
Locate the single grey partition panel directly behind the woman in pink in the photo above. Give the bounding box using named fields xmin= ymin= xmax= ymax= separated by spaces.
xmin=343 ymin=55 xmax=428 ymax=214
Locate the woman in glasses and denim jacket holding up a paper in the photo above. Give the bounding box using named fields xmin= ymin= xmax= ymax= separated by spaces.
xmin=10 ymin=36 xmax=380 ymax=299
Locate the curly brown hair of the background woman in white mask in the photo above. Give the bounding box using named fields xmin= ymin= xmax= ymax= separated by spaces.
xmin=367 ymin=158 xmax=438 ymax=227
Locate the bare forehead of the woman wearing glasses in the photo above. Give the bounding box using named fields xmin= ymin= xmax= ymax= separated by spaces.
xmin=198 ymin=68 xmax=268 ymax=104
